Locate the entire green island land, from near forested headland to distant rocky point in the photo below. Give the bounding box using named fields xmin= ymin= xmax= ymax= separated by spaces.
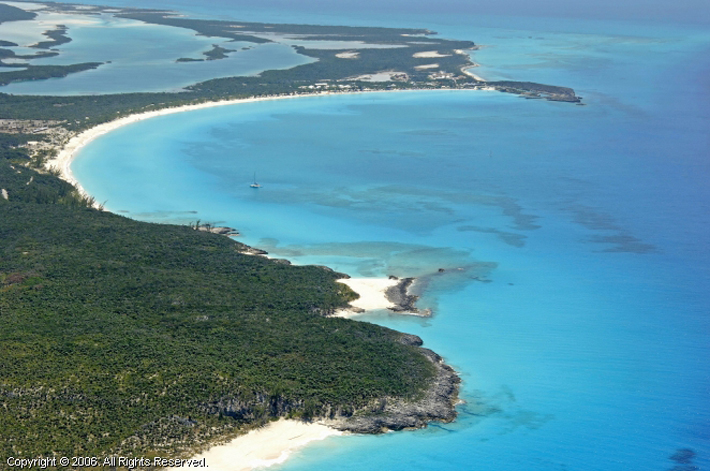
xmin=0 ymin=3 xmax=579 ymax=467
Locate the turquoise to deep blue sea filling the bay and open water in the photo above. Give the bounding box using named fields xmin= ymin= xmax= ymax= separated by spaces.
xmin=64 ymin=2 xmax=710 ymax=471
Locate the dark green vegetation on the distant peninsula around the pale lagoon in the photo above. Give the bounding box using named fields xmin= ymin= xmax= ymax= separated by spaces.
xmin=0 ymin=4 xmax=579 ymax=105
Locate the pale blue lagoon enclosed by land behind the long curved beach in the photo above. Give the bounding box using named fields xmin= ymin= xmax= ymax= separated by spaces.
xmin=0 ymin=14 xmax=314 ymax=95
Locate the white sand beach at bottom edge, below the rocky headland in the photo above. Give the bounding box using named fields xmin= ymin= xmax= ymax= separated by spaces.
xmin=167 ymin=419 xmax=343 ymax=471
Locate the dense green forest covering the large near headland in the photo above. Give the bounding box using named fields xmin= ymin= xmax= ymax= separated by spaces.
xmin=0 ymin=144 xmax=433 ymax=460
